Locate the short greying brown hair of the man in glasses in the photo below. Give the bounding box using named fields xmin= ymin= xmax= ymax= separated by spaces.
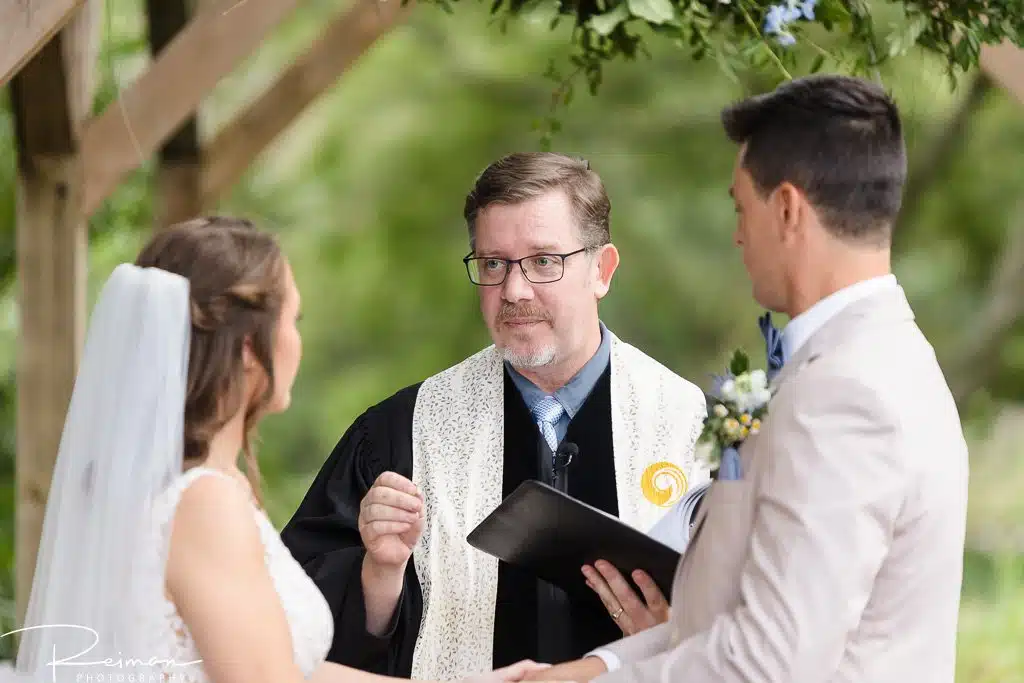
xmin=463 ymin=152 xmax=611 ymax=249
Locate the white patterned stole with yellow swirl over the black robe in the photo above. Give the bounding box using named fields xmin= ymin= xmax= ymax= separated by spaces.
xmin=412 ymin=335 xmax=708 ymax=681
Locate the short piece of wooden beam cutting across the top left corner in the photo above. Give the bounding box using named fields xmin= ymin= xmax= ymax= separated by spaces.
xmin=0 ymin=0 xmax=85 ymax=87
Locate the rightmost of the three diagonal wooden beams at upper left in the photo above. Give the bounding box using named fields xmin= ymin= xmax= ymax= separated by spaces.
xmin=203 ymin=0 xmax=414 ymax=208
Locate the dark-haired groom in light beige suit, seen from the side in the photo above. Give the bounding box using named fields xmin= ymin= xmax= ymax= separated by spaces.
xmin=543 ymin=76 xmax=968 ymax=683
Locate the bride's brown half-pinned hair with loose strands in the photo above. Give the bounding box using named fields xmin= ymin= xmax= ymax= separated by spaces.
xmin=135 ymin=216 xmax=285 ymax=505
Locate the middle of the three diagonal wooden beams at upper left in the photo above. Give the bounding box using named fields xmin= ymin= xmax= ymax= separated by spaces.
xmin=82 ymin=0 xmax=300 ymax=215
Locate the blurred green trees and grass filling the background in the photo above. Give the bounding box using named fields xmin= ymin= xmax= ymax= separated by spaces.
xmin=0 ymin=0 xmax=1024 ymax=683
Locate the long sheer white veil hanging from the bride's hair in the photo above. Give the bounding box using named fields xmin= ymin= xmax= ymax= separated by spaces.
xmin=17 ymin=264 xmax=190 ymax=682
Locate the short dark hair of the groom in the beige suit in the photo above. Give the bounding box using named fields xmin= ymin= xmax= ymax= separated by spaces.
xmin=722 ymin=75 xmax=906 ymax=244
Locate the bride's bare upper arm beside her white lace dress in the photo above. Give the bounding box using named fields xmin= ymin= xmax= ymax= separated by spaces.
xmin=167 ymin=476 xmax=304 ymax=683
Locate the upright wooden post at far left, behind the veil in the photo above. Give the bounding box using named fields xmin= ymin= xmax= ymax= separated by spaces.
xmin=11 ymin=0 xmax=93 ymax=623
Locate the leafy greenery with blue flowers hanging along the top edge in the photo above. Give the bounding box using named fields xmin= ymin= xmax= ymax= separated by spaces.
xmin=454 ymin=0 xmax=1024 ymax=140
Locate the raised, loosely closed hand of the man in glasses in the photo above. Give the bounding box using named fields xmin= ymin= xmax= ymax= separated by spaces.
xmin=358 ymin=472 xmax=423 ymax=573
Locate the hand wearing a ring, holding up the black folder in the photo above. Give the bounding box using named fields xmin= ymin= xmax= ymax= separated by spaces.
xmin=583 ymin=560 xmax=669 ymax=636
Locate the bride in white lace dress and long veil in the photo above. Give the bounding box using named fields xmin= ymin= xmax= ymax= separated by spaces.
xmin=17 ymin=218 xmax=557 ymax=683
